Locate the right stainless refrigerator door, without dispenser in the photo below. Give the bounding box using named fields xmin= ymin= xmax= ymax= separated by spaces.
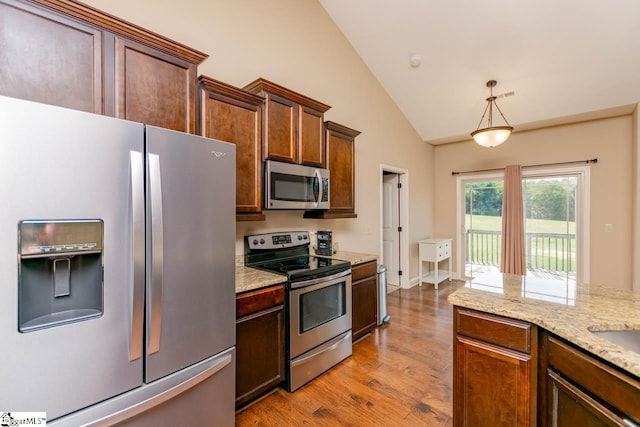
xmin=145 ymin=126 xmax=236 ymax=383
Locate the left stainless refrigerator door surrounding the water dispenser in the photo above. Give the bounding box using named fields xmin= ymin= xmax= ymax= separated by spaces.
xmin=0 ymin=97 xmax=144 ymax=420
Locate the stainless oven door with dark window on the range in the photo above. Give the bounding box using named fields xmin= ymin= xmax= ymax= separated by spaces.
xmin=289 ymin=270 xmax=351 ymax=359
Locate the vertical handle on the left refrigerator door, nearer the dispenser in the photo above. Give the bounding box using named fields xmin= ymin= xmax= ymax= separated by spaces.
xmin=129 ymin=151 xmax=145 ymax=361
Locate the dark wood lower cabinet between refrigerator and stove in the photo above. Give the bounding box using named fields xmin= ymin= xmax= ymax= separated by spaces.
xmin=236 ymin=285 xmax=285 ymax=408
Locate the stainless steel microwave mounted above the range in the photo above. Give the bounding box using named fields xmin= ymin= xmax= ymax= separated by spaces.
xmin=264 ymin=160 xmax=329 ymax=209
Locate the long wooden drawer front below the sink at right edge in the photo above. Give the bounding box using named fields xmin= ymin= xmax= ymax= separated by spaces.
xmin=547 ymin=336 xmax=640 ymax=419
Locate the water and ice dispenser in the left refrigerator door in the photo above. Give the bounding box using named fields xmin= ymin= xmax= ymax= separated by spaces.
xmin=18 ymin=220 xmax=104 ymax=332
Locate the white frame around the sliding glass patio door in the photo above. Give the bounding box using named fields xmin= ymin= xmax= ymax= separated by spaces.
xmin=456 ymin=166 xmax=591 ymax=283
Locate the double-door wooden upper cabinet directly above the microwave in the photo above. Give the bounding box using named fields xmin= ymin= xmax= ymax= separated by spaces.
xmin=244 ymin=78 xmax=331 ymax=167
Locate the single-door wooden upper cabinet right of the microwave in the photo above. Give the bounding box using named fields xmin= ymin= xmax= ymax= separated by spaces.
xmin=304 ymin=121 xmax=360 ymax=219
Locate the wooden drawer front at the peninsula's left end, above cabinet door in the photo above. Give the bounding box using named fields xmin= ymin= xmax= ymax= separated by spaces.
xmin=455 ymin=309 xmax=532 ymax=354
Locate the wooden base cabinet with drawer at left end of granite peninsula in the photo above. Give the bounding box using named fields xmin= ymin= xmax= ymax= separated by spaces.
xmin=453 ymin=307 xmax=537 ymax=427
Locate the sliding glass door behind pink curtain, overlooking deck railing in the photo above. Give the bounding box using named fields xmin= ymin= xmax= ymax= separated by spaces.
xmin=457 ymin=167 xmax=589 ymax=281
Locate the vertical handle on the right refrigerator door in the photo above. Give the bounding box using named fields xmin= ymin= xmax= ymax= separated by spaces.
xmin=148 ymin=153 xmax=164 ymax=354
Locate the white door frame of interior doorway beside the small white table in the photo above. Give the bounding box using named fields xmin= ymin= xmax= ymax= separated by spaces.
xmin=378 ymin=164 xmax=411 ymax=289
